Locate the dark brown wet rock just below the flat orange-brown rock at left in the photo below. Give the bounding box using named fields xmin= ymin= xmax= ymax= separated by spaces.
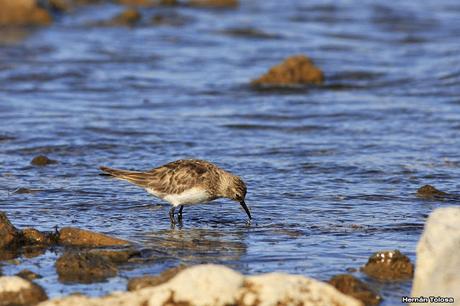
xmin=56 ymin=252 xmax=118 ymax=284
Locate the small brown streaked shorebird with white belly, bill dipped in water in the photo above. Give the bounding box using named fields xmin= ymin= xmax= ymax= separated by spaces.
xmin=100 ymin=160 xmax=252 ymax=224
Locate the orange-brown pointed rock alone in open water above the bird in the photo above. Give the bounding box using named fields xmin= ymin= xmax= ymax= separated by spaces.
xmin=251 ymin=55 xmax=324 ymax=86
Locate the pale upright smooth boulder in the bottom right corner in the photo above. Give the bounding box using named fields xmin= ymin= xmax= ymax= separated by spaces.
xmin=411 ymin=207 xmax=460 ymax=305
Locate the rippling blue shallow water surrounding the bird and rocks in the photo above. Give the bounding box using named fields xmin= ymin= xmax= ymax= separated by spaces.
xmin=0 ymin=0 xmax=460 ymax=306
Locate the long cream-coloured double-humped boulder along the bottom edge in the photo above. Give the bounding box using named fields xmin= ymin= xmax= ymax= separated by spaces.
xmin=40 ymin=265 xmax=363 ymax=306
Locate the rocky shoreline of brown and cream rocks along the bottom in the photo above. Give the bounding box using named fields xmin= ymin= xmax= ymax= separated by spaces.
xmin=0 ymin=207 xmax=460 ymax=306
